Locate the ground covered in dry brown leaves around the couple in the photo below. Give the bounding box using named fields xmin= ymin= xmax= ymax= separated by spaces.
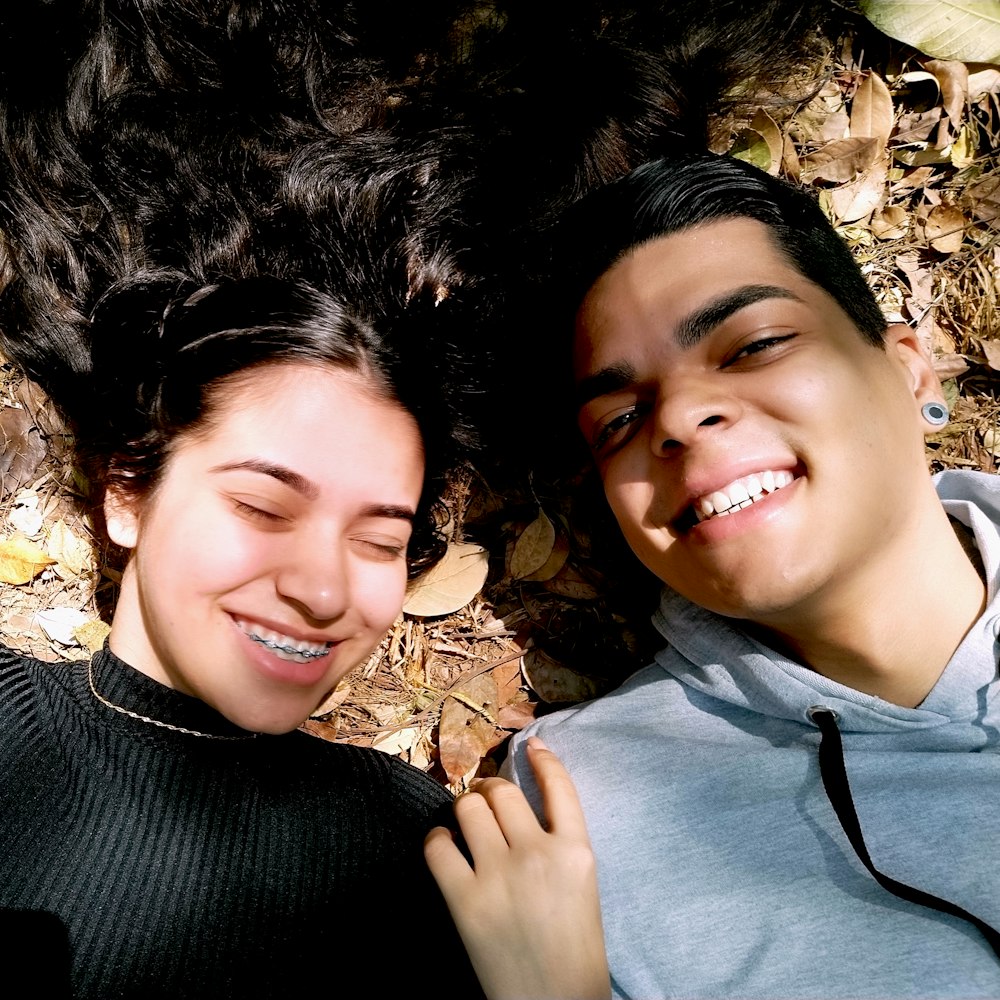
xmin=0 ymin=17 xmax=1000 ymax=790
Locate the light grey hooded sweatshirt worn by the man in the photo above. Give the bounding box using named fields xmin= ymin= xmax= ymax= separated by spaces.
xmin=505 ymin=472 xmax=1000 ymax=1000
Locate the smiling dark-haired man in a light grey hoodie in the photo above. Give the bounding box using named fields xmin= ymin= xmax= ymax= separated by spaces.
xmin=508 ymin=155 xmax=1000 ymax=1000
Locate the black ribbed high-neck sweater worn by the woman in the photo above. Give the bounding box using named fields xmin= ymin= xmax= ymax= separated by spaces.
xmin=0 ymin=647 xmax=478 ymax=1000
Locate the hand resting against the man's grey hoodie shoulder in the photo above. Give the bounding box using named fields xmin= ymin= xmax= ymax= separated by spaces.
xmin=424 ymin=736 xmax=611 ymax=1000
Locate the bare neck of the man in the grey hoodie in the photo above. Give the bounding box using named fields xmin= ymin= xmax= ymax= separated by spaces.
xmin=749 ymin=500 xmax=986 ymax=708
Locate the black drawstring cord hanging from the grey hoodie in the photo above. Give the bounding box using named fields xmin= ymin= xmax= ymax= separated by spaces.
xmin=809 ymin=707 xmax=1000 ymax=958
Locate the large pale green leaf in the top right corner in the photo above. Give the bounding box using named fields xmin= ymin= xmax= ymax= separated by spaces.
xmin=861 ymin=0 xmax=1000 ymax=63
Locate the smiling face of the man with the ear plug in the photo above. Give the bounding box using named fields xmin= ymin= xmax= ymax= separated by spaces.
xmin=574 ymin=219 xmax=939 ymax=628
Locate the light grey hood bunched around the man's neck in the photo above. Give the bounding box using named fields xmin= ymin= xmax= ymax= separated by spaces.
xmin=653 ymin=472 xmax=1000 ymax=733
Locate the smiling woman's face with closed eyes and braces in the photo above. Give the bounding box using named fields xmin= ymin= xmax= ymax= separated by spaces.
xmin=106 ymin=364 xmax=424 ymax=733
